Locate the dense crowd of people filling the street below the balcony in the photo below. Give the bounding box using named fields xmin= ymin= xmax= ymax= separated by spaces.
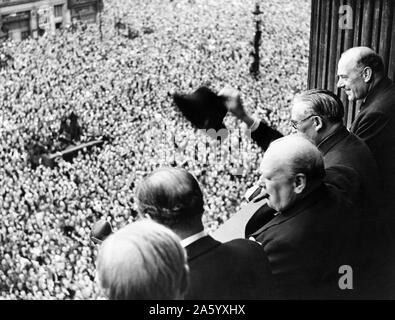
xmin=0 ymin=0 xmax=309 ymax=299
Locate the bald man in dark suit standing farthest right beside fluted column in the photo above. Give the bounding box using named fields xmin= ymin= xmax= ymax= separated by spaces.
xmin=337 ymin=47 xmax=395 ymax=220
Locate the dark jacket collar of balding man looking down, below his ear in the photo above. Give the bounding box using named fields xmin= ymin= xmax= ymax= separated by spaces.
xmin=252 ymin=184 xmax=328 ymax=238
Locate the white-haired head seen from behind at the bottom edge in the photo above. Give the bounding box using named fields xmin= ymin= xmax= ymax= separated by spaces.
xmin=97 ymin=219 xmax=189 ymax=300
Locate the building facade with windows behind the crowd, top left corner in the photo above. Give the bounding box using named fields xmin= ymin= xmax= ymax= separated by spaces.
xmin=0 ymin=0 xmax=101 ymax=41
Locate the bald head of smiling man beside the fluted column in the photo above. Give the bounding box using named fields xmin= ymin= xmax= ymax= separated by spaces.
xmin=337 ymin=47 xmax=384 ymax=101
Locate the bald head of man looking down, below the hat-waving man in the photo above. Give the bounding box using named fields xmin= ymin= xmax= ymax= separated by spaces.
xmin=260 ymin=135 xmax=325 ymax=211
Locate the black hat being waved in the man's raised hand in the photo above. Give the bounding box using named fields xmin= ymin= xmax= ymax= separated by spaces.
xmin=173 ymin=87 xmax=227 ymax=131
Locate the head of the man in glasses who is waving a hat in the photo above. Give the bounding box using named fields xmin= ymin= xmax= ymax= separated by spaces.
xmin=291 ymin=89 xmax=344 ymax=145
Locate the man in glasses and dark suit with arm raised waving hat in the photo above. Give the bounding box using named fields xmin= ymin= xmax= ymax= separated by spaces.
xmin=220 ymin=89 xmax=392 ymax=298
